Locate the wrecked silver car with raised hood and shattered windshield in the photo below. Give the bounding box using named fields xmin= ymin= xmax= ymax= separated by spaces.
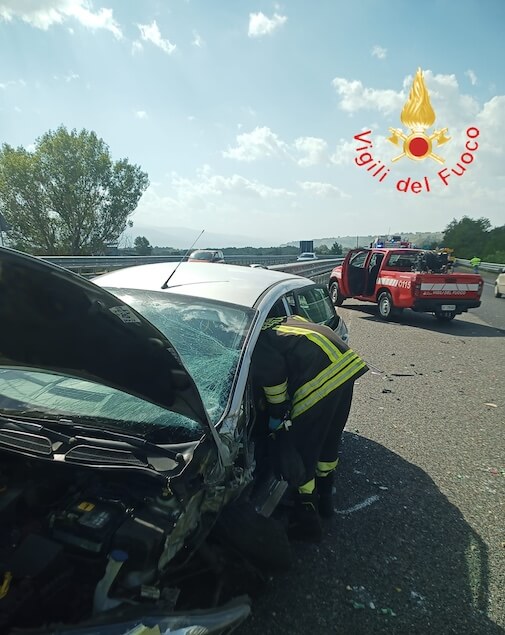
xmin=0 ymin=248 xmax=347 ymax=635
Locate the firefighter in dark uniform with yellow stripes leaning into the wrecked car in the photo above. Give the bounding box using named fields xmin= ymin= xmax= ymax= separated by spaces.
xmin=253 ymin=316 xmax=368 ymax=542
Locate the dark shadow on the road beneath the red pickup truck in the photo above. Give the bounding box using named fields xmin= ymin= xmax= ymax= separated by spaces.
xmin=337 ymin=302 xmax=505 ymax=337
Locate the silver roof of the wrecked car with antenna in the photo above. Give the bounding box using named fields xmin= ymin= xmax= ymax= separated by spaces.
xmin=93 ymin=262 xmax=314 ymax=307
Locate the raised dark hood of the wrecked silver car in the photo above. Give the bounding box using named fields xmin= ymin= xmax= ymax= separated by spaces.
xmin=0 ymin=247 xmax=214 ymax=436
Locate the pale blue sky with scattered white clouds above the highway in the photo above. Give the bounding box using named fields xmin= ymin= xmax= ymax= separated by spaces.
xmin=0 ymin=0 xmax=505 ymax=244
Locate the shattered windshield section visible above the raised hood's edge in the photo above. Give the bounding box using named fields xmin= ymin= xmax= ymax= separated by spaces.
xmin=108 ymin=289 xmax=254 ymax=424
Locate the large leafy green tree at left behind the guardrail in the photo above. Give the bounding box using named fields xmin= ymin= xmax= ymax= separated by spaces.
xmin=0 ymin=126 xmax=149 ymax=254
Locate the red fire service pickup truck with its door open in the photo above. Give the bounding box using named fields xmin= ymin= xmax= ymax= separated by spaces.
xmin=329 ymin=248 xmax=484 ymax=321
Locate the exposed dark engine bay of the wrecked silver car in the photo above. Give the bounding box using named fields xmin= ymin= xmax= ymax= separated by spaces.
xmin=0 ymin=452 xmax=211 ymax=633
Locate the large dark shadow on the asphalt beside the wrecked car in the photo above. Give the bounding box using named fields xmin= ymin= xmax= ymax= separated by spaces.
xmin=237 ymin=433 xmax=505 ymax=635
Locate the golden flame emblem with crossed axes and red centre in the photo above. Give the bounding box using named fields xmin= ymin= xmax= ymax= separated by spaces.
xmin=388 ymin=68 xmax=450 ymax=163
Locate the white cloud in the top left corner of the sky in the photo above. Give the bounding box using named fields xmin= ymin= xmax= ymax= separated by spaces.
xmin=0 ymin=0 xmax=123 ymax=40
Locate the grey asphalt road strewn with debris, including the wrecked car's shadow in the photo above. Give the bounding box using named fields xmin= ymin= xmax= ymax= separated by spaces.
xmin=237 ymin=296 xmax=505 ymax=635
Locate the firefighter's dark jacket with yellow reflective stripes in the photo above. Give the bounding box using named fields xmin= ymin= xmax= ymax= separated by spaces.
xmin=253 ymin=316 xmax=368 ymax=419
